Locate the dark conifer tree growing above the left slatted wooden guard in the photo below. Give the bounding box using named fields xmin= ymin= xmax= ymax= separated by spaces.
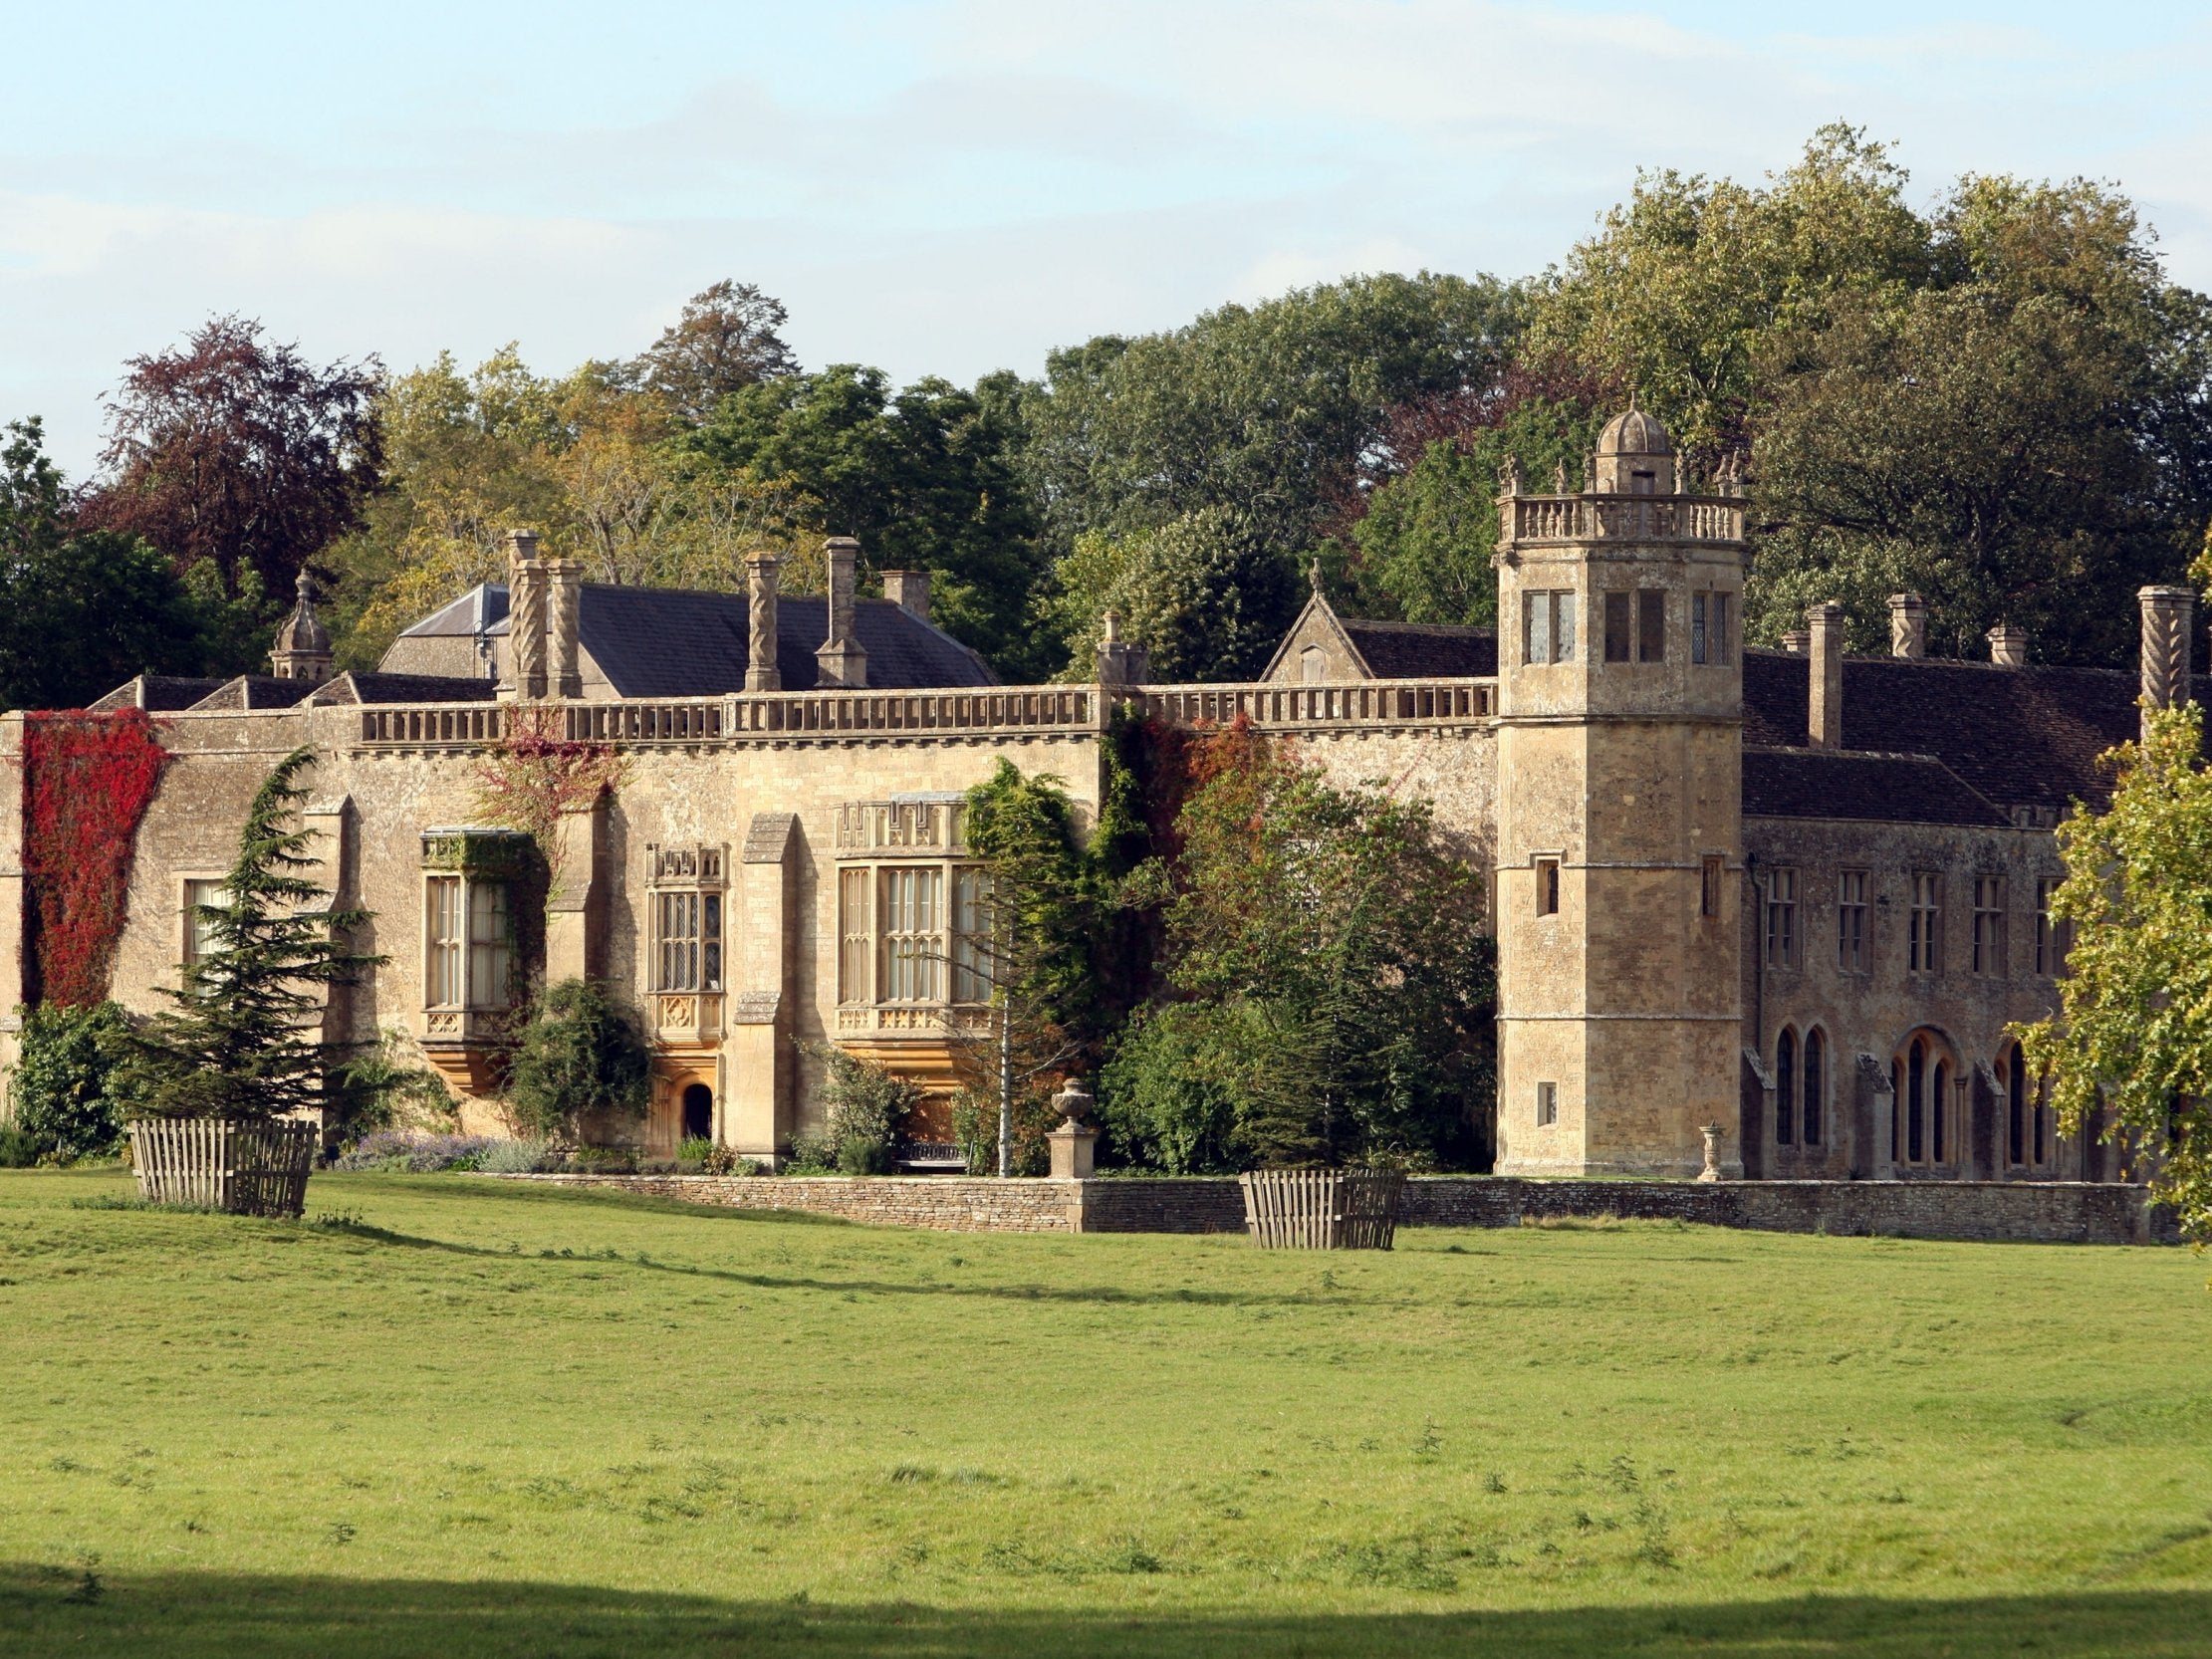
xmin=118 ymin=748 xmax=382 ymax=1119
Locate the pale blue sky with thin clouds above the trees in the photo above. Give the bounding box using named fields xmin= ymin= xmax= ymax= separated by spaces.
xmin=0 ymin=0 xmax=2212 ymax=473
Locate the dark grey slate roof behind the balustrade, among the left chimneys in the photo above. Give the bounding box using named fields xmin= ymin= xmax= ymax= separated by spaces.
xmin=400 ymin=582 xmax=998 ymax=697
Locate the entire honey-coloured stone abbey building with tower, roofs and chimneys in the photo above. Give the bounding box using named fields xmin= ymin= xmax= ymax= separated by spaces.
xmin=0 ymin=411 xmax=2192 ymax=1181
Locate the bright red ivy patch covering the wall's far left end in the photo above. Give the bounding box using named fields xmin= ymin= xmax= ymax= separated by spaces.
xmin=22 ymin=708 xmax=168 ymax=1009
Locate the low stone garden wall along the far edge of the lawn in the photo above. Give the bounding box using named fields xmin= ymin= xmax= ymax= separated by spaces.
xmin=493 ymin=1175 xmax=2176 ymax=1243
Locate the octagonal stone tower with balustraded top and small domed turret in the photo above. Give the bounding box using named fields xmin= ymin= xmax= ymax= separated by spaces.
xmin=1495 ymin=409 xmax=1743 ymax=1175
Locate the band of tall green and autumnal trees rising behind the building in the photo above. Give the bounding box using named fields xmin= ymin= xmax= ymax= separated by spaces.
xmin=0 ymin=126 xmax=2212 ymax=706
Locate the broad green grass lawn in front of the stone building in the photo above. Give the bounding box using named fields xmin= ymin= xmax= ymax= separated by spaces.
xmin=0 ymin=1172 xmax=2212 ymax=1659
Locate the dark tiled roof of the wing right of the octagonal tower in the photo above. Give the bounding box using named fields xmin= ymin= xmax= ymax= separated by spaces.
xmin=1743 ymin=650 xmax=2167 ymax=812
